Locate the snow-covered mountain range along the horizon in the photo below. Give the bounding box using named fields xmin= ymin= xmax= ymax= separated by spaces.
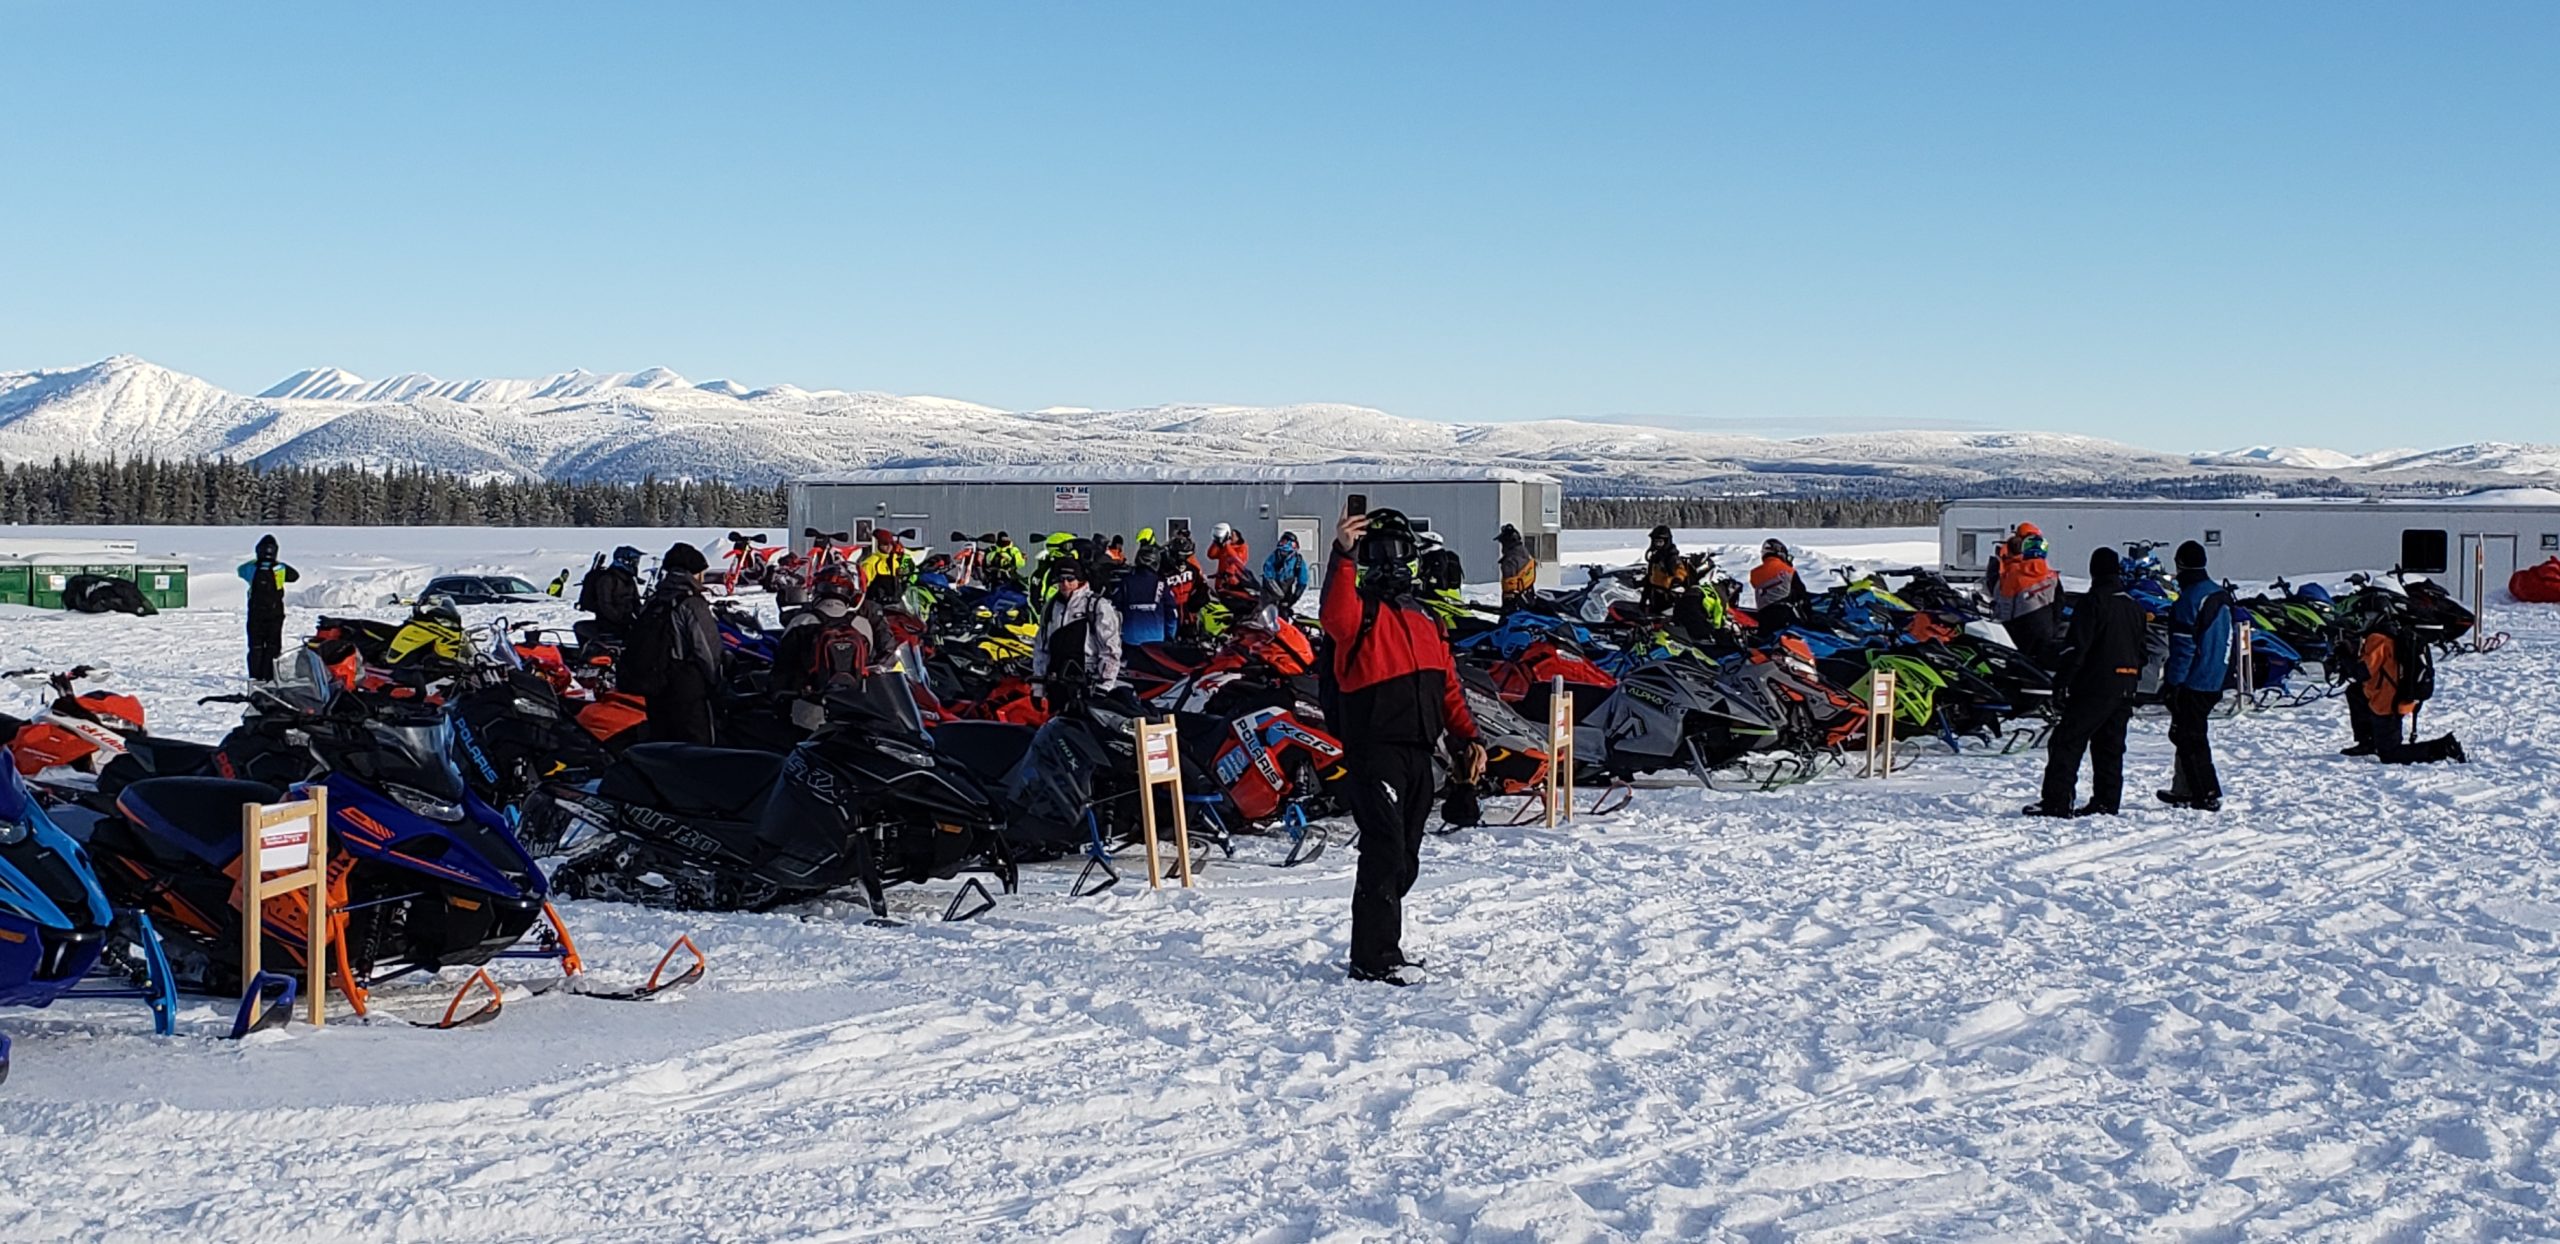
xmin=0 ymin=356 xmax=2560 ymax=497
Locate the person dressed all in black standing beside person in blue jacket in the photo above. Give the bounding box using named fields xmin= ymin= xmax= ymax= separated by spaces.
xmin=2028 ymin=548 xmax=2145 ymax=817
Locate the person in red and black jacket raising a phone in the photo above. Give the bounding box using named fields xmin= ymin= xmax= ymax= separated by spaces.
xmin=1324 ymin=509 xmax=1485 ymax=985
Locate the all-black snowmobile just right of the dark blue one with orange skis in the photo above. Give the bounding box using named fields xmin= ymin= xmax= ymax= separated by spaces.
xmin=525 ymin=673 xmax=1016 ymax=921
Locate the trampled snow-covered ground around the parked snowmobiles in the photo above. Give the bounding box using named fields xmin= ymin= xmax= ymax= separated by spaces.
xmin=0 ymin=530 xmax=2560 ymax=1241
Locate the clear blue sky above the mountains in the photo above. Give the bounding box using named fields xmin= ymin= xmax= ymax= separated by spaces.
xmin=0 ymin=0 xmax=2560 ymax=451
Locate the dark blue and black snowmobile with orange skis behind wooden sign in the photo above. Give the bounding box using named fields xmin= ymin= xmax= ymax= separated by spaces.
xmin=90 ymin=683 xmax=573 ymax=1014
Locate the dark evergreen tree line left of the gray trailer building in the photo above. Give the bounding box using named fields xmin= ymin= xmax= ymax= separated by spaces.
xmin=0 ymin=458 xmax=788 ymax=527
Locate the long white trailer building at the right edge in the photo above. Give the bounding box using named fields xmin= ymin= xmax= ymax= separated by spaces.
xmin=1938 ymin=494 xmax=2560 ymax=609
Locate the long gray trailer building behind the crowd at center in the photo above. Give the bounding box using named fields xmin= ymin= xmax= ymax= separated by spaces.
xmin=788 ymin=466 xmax=1564 ymax=584
